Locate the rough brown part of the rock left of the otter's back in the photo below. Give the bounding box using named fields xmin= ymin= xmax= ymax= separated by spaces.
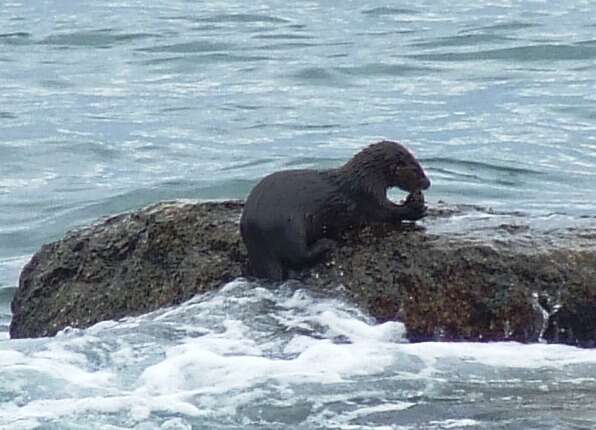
xmin=10 ymin=202 xmax=246 ymax=338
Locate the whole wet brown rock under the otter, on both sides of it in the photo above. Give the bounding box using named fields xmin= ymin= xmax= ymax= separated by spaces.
xmin=10 ymin=202 xmax=596 ymax=346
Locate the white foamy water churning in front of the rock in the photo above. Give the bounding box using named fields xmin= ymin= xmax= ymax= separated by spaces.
xmin=0 ymin=280 xmax=596 ymax=429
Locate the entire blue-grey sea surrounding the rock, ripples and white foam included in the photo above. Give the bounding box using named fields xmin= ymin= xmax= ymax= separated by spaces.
xmin=0 ymin=0 xmax=596 ymax=430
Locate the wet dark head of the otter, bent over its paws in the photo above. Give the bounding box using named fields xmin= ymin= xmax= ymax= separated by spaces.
xmin=369 ymin=140 xmax=430 ymax=193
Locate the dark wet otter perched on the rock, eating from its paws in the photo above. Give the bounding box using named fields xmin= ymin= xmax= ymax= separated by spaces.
xmin=240 ymin=141 xmax=430 ymax=280
